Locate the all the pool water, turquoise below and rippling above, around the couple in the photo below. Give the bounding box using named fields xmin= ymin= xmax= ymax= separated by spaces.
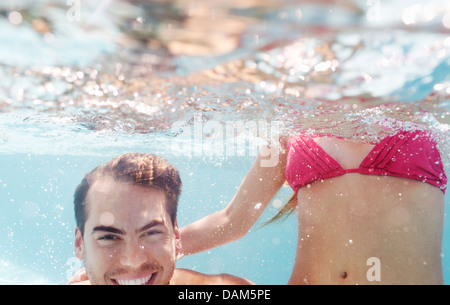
xmin=0 ymin=1 xmax=450 ymax=284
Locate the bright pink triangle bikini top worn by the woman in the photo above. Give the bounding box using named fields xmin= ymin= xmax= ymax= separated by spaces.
xmin=285 ymin=130 xmax=447 ymax=194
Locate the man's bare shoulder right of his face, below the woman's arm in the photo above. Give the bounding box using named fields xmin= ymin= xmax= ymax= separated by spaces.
xmin=170 ymin=269 xmax=254 ymax=285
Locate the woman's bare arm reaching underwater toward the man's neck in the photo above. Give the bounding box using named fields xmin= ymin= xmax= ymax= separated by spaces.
xmin=180 ymin=141 xmax=286 ymax=255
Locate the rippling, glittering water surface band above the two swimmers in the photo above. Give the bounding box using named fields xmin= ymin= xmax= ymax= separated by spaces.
xmin=0 ymin=2 xmax=450 ymax=150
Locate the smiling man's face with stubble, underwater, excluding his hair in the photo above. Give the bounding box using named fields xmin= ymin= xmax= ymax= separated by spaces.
xmin=75 ymin=177 xmax=181 ymax=285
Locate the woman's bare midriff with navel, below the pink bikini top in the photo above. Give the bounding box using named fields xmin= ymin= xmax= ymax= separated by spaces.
xmin=289 ymin=173 xmax=444 ymax=284
